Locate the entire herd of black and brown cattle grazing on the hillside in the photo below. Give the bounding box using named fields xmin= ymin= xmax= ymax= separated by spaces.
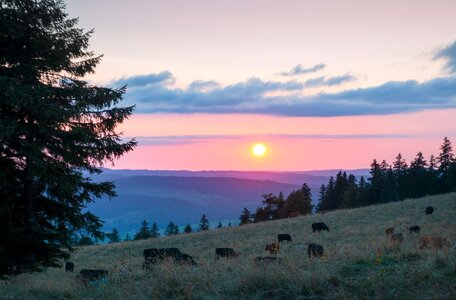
xmin=65 ymin=206 xmax=450 ymax=284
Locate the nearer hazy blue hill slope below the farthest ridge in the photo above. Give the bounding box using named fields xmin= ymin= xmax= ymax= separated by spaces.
xmin=88 ymin=176 xmax=299 ymax=233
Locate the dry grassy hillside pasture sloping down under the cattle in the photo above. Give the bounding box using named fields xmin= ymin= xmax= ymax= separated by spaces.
xmin=0 ymin=194 xmax=456 ymax=299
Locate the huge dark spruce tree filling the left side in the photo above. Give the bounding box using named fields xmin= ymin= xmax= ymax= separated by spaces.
xmin=0 ymin=0 xmax=136 ymax=277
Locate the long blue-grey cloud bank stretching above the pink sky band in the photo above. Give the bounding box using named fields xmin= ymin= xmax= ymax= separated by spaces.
xmin=116 ymin=72 xmax=456 ymax=116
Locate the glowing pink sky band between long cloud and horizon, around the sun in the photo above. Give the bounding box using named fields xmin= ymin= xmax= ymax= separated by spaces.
xmin=110 ymin=109 xmax=456 ymax=171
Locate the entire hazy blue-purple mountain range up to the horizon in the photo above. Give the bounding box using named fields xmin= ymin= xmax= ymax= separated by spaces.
xmin=88 ymin=169 xmax=368 ymax=234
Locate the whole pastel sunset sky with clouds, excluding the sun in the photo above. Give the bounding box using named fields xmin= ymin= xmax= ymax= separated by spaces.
xmin=66 ymin=0 xmax=456 ymax=171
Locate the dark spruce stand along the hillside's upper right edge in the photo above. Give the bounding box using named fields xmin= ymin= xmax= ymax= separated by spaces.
xmin=317 ymin=137 xmax=456 ymax=212
